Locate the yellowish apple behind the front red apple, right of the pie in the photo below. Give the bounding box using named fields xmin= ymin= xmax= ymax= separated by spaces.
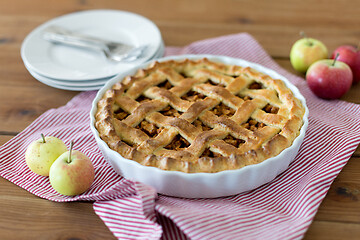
xmin=290 ymin=33 xmax=329 ymax=73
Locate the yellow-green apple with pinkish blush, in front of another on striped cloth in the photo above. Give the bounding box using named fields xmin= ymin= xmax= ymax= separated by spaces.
xmin=49 ymin=142 xmax=95 ymax=196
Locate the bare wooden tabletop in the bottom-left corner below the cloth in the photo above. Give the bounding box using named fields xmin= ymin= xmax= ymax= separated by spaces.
xmin=0 ymin=178 xmax=115 ymax=240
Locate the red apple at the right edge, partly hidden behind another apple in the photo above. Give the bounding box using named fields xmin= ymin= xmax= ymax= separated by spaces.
xmin=331 ymin=45 xmax=360 ymax=83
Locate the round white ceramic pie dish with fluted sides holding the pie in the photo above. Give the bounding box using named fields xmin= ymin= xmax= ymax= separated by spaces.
xmin=90 ymin=55 xmax=309 ymax=198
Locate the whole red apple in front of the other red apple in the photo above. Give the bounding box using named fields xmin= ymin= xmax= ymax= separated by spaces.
xmin=306 ymin=54 xmax=353 ymax=99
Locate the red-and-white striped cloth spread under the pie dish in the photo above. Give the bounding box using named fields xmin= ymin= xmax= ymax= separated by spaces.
xmin=0 ymin=33 xmax=360 ymax=239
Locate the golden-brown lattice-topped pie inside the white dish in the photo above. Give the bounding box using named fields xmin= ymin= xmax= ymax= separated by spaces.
xmin=95 ymin=58 xmax=305 ymax=173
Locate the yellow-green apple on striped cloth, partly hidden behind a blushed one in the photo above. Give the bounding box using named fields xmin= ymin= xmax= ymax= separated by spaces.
xmin=25 ymin=134 xmax=67 ymax=176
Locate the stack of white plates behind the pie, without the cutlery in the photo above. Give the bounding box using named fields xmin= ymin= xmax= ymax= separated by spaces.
xmin=21 ymin=10 xmax=165 ymax=91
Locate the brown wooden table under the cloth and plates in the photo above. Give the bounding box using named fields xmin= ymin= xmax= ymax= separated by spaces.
xmin=0 ymin=0 xmax=360 ymax=239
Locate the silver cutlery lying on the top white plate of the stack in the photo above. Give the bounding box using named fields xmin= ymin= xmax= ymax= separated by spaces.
xmin=42 ymin=26 xmax=147 ymax=62
